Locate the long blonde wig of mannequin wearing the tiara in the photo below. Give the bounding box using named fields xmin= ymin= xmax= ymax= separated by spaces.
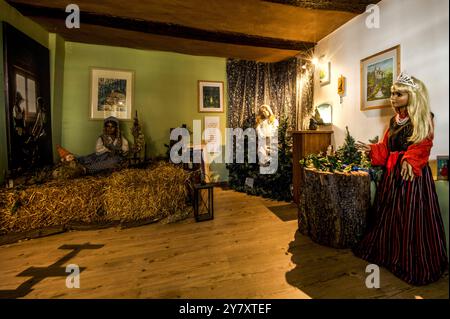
xmin=392 ymin=77 xmax=434 ymax=143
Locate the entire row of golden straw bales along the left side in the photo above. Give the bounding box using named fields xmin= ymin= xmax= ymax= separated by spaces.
xmin=0 ymin=163 xmax=192 ymax=234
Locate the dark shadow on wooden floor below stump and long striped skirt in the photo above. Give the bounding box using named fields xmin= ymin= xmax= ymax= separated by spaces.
xmin=286 ymin=231 xmax=449 ymax=299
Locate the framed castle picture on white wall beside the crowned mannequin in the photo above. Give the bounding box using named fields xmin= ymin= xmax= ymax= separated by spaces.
xmin=361 ymin=45 xmax=400 ymax=111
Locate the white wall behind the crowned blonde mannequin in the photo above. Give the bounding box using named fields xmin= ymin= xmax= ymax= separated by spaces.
xmin=314 ymin=0 xmax=449 ymax=159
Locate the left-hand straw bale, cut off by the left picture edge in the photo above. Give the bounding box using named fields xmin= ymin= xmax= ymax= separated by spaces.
xmin=0 ymin=177 xmax=105 ymax=233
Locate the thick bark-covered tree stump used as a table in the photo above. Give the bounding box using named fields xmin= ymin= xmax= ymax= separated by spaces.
xmin=298 ymin=169 xmax=370 ymax=248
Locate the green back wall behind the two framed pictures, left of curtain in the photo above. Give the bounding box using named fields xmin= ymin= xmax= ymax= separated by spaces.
xmin=61 ymin=42 xmax=227 ymax=180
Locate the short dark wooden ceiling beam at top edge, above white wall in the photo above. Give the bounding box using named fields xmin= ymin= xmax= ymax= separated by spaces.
xmin=263 ymin=0 xmax=380 ymax=14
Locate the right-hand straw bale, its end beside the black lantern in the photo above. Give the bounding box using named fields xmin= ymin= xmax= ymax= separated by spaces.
xmin=103 ymin=163 xmax=191 ymax=223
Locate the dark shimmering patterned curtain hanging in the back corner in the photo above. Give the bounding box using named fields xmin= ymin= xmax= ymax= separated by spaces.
xmin=227 ymin=58 xmax=312 ymax=130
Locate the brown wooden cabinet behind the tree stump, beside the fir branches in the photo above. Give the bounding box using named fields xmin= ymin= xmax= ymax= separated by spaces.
xmin=292 ymin=131 xmax=333 ymax=204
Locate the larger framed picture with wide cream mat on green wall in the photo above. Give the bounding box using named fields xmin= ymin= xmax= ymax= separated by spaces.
xmin=90 ymin=68 xmax=134 ymax=120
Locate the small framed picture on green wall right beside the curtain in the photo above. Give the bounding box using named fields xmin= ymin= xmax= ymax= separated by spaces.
xmin=198 ymin=81 xmax=223 ymax=113
